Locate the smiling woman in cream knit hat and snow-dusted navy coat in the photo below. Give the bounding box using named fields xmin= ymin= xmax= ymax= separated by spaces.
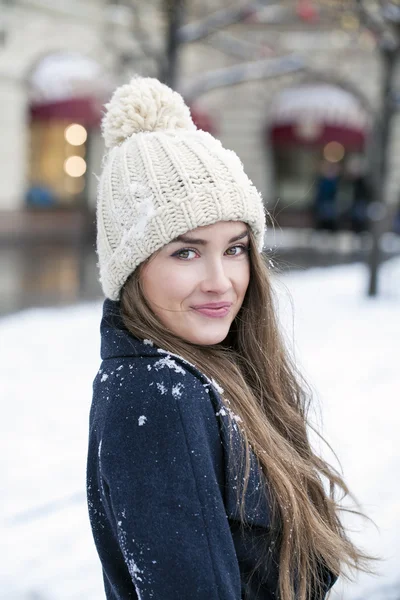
xmin=87 ymin=78 xmax=366 ymax=600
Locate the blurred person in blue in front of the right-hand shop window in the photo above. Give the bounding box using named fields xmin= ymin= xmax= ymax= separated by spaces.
xmin=313 ymin=160 xmax=340 ymax=231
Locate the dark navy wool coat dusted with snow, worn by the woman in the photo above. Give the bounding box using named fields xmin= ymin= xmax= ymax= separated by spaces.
xmin=87 ymin=300 xmax=331 ymax=600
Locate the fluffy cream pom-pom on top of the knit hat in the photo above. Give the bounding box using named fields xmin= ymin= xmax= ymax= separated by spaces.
xmin=102 ymin=77 xmax=196 ymax=148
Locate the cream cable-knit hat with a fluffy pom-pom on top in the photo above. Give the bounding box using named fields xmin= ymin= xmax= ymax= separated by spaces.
xmin=97 ymin=77 xmax=265 ymax=300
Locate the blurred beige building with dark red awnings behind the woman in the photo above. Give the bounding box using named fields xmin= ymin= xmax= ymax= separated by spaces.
xmin=0 ymin=0 xmax=400 ymax=311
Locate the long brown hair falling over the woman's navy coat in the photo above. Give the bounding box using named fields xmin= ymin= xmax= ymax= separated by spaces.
xmin=121 ymin=226 xmax=370 ymax=600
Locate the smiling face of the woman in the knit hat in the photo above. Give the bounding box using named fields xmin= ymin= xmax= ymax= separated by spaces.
xmin=140 ymin=221 xmax=250 ymax=346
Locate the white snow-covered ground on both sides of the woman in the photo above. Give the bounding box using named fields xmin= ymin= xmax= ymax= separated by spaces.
xmin=0 ymin=259 xmax=400 ymax=600
